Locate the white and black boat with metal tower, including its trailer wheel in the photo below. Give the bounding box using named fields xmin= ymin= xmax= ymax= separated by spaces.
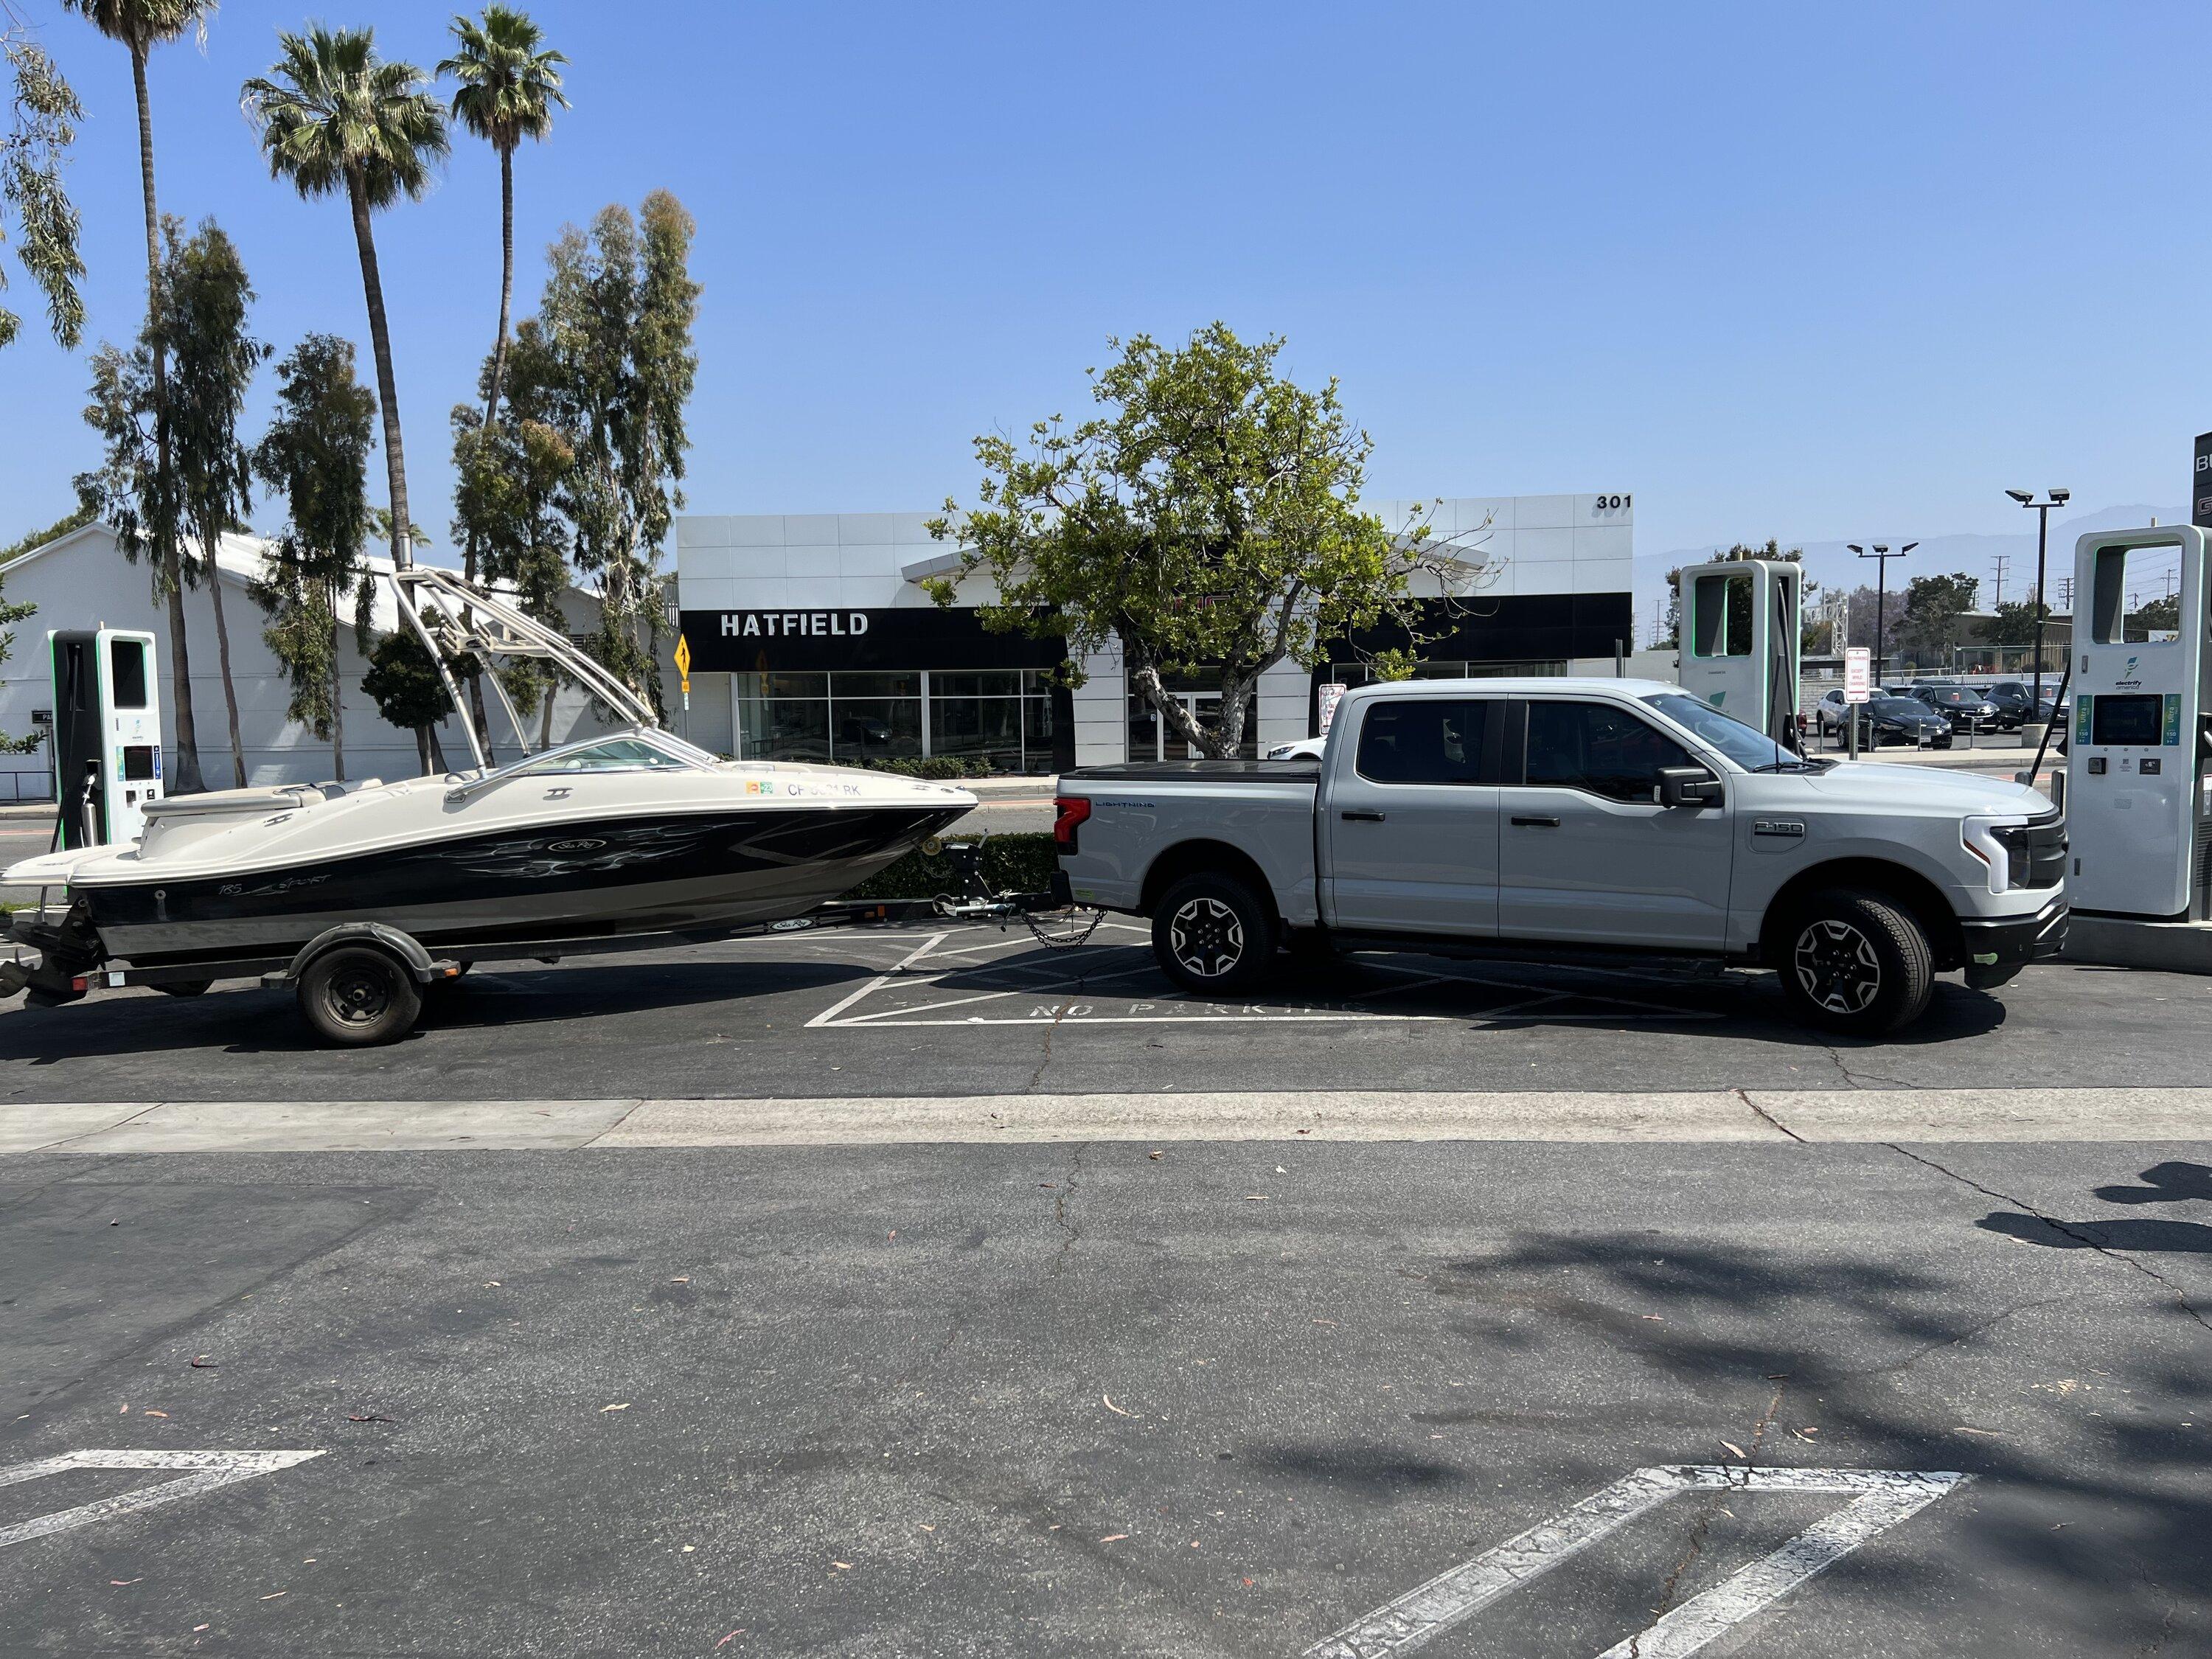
xmin=0 ymin=568 xmax=975 ymax=1042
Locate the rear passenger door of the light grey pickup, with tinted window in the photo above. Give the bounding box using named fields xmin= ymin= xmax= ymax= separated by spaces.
xmin=1321 ymin=695 xmax=1509 ymax=938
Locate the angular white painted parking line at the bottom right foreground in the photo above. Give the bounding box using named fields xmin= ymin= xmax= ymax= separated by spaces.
xmin=1303 ymin=1464 xmax=1969 ymax=1659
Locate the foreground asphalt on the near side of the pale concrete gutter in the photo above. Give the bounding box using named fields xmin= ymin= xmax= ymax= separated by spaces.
xmin=0 ymin=1141 xmax=2212 ymax=1659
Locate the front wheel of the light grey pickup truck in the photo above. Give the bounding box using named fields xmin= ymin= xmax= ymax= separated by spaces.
xmin=1774 ymin=887 xmax=1935 ymax=1037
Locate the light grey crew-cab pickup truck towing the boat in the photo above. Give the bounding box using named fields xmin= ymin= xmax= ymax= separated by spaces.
xmin=1053 ymin=679 xmax=2066 ymax=1035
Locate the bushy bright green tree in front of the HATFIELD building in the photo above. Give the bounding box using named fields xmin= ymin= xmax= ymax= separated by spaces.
xmin=929 ymin=323 xmax=1427 ymax=757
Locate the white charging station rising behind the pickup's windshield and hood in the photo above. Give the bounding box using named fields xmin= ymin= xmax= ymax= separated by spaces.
xmin=1674 ymin=560 xmax=1805 ymax=750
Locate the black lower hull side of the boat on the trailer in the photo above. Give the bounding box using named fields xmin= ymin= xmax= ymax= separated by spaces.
xmin=73 ymin=805 xmax=964 ymax=967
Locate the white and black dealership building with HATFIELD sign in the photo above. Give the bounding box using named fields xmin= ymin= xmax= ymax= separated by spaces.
xmin=677 ymin=495 xmax=1635 ymax=774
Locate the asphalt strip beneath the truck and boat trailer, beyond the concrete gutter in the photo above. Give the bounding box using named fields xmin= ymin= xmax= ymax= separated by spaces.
xmin=0 ymin=918 xmax=2212 ymax=1102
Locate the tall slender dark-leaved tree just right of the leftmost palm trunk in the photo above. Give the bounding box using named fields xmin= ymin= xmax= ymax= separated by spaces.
xmin=159 ymin=219 xmax=270 ymax=790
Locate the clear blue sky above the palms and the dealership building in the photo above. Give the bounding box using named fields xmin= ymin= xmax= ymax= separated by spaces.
xmin=0 ymin=0 xmax=2212 ymax=597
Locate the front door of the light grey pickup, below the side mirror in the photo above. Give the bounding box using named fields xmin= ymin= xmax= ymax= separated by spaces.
xmin=1498 ymin=697 xmax=1734 ymax=951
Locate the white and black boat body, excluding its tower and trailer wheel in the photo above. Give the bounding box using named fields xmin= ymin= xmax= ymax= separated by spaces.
xmin=0 ymin=728 xmax=975 ymax=969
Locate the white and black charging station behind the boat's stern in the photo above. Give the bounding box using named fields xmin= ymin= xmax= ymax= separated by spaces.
xmin=46 ymin=628 xmax=161 ymax=847
